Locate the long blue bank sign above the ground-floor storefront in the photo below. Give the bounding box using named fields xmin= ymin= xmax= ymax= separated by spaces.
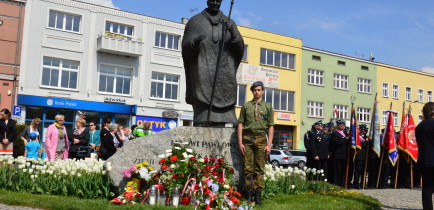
xmin=18 ymin=95 xmax=136 ymax=114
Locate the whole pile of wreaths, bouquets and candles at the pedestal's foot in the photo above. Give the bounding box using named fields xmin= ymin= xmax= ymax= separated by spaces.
xmin=112 ymin=142 xmax=253 ymax=209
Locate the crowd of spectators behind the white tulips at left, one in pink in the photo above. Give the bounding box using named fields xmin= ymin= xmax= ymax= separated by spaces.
xmin=0 ymin=109 xmax=153 ymax=161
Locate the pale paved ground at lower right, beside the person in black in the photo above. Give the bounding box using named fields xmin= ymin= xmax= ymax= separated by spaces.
xmin=357 ymin=188 xmax=428 ymax=210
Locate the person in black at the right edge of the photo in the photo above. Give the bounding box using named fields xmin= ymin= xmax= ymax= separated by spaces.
xmin=416 ymin=102 xmax=434 ymax=210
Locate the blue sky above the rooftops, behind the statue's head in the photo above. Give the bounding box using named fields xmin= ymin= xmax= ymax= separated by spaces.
xmin=81 ymin=0 xmax=434 ymax=73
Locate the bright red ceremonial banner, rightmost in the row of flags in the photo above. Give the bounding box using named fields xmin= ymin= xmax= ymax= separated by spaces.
xmin=398 ymin=114 xmax=419 ymax=162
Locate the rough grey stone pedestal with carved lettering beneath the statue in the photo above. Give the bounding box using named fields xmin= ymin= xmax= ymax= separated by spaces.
xmin=107 ymin=127 xmax=244 ymax=193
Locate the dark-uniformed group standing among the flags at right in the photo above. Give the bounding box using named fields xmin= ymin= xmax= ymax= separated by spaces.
xmin=304 ymin=120 xmax=420 ymax=189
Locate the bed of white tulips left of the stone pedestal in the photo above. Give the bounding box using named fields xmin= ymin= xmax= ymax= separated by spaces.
xmin=0 ymin=156 xmax=113 ymax=198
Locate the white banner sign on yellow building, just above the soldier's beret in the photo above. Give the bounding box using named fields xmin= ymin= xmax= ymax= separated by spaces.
xmin=237 ymin=63 xmax=279 ymax=88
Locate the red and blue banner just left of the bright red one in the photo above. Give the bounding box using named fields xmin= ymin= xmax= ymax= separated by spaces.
xmin=383 ymin=110 xmax=398 ymax=166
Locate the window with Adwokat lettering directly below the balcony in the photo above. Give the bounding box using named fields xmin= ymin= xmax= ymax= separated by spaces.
xmin=98 ymin=64 xmax=132 ymax=95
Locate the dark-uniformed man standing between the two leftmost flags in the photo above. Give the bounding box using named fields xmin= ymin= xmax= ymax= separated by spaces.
xmin=353 ymin=124 xmax=369 ymax=189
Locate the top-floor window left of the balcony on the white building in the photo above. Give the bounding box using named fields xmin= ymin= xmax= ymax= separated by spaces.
xmin=48 ymin=10 xmax=81 ymax=32
